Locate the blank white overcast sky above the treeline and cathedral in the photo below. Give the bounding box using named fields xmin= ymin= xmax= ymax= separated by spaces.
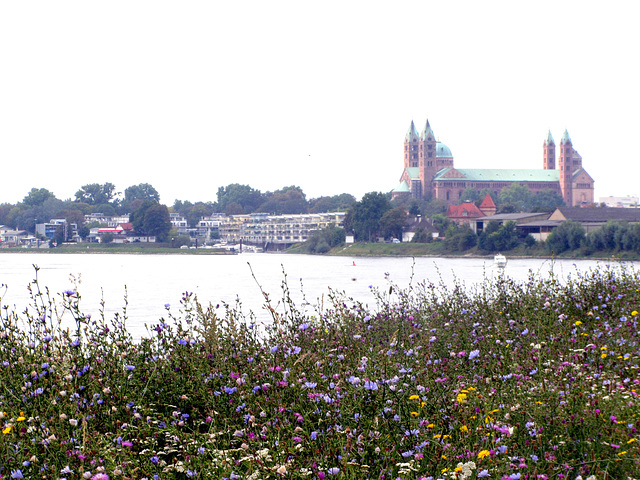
xmin=0 ymin=0 xmax=640 ymax=205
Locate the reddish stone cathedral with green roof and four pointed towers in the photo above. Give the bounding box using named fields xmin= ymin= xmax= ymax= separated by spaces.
xmin=391 ymin=120 xmax=593 ymax=207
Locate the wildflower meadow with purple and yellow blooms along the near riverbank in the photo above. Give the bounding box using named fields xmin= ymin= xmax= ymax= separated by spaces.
xmin=0 ymin=266 xmax=640 ymax=480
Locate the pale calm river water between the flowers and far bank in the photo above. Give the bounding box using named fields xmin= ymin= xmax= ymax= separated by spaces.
xmin=0 ymin=253 xmax=632 ymax=336
